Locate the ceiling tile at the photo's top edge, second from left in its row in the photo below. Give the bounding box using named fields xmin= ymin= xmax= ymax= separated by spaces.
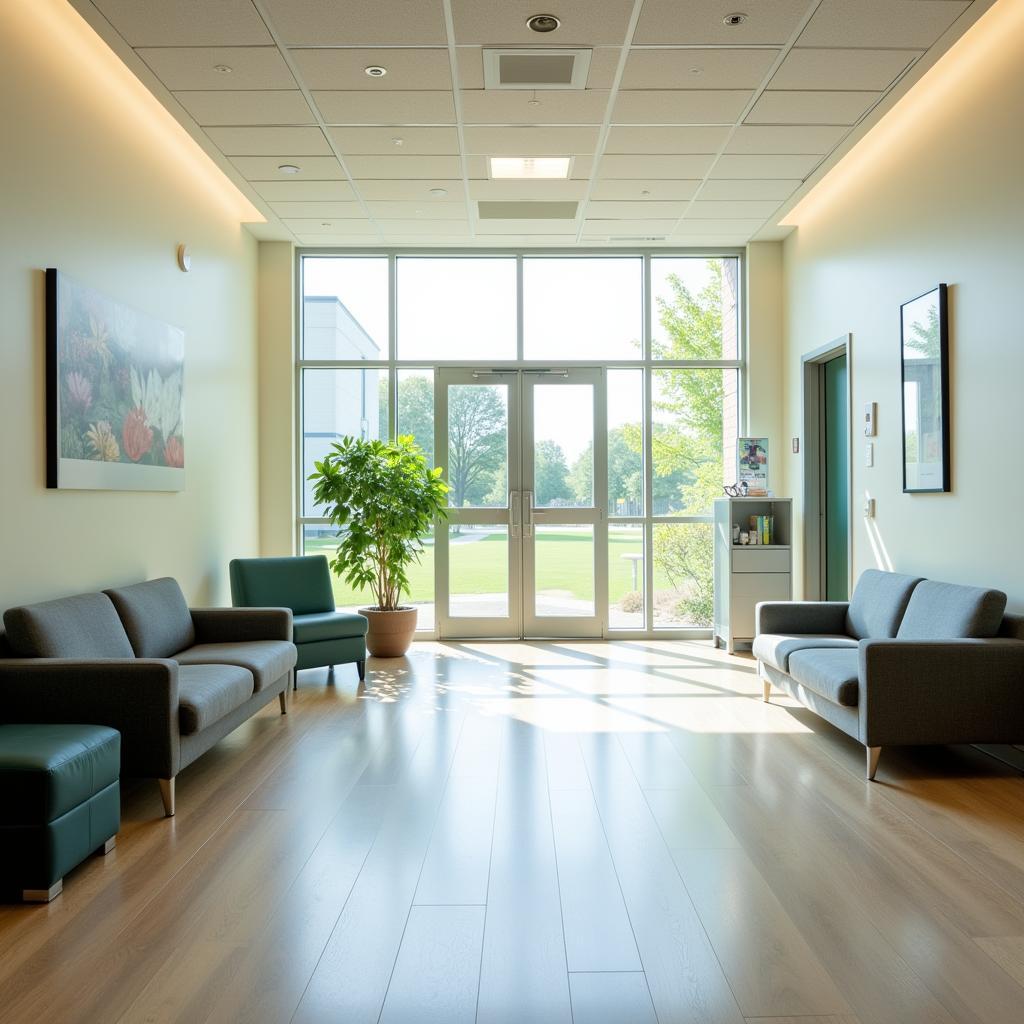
xmin=263 ymin=0 xmax=445 ymax=46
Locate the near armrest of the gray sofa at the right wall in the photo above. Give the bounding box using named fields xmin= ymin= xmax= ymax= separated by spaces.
xmin=858 ymin=639 xmax=1024 ymax=746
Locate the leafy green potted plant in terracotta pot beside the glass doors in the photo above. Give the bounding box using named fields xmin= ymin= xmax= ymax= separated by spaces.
xmin=309 ymin=435 xmax=449 ymax=657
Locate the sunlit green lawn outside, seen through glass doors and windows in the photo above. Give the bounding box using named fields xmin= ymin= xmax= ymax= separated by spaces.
xmin=306 ymin=529 xmax=643 ymax=607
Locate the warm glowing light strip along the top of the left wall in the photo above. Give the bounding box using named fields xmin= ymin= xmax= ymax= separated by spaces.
xmin=4 ymin=0 xmax=266 ymax=223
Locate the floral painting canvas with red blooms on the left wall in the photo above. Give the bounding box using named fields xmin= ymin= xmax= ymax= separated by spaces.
xmin=46 ymin=269 xmax=185 ymax=490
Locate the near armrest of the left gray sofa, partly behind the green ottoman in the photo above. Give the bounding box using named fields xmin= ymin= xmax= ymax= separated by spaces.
xmin=0 ymin=657 xmax=180 ymax=778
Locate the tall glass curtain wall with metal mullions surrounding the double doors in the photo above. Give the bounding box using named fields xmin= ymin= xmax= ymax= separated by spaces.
xmin=296 ymin=251 xmax=744 ymax=637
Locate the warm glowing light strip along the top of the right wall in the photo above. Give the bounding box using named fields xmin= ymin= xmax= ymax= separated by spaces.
xmin=780 ymin=0 xmax=1024 ymax=226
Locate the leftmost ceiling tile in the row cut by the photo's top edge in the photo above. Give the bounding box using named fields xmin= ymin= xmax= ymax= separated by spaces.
xmin=93 ymin=0 xmax=273 ymax=46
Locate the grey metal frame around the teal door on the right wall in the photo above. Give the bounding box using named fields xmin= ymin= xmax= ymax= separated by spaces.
xmin=800 ymin=334 xmax=854 ymax=601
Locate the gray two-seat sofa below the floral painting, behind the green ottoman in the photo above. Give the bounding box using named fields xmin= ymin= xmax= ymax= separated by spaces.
xmin=0 ymin=579 xmax=296 ymax=816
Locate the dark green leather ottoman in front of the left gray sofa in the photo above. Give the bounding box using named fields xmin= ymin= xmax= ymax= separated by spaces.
xmin=0 ymin=725 xmax=121 ymax=902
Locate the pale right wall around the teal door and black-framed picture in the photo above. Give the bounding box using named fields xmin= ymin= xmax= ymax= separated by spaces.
xmin=778 ymin=0 xmax=1024 ymax=611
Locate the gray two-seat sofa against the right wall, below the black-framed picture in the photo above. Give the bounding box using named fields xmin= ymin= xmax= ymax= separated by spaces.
xmin=753 ymin=569 xmax=1024 ymax=779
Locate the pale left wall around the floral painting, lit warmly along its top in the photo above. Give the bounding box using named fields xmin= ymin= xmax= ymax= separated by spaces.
xmin=0 ymin=0 xmax=259 ymax=610
